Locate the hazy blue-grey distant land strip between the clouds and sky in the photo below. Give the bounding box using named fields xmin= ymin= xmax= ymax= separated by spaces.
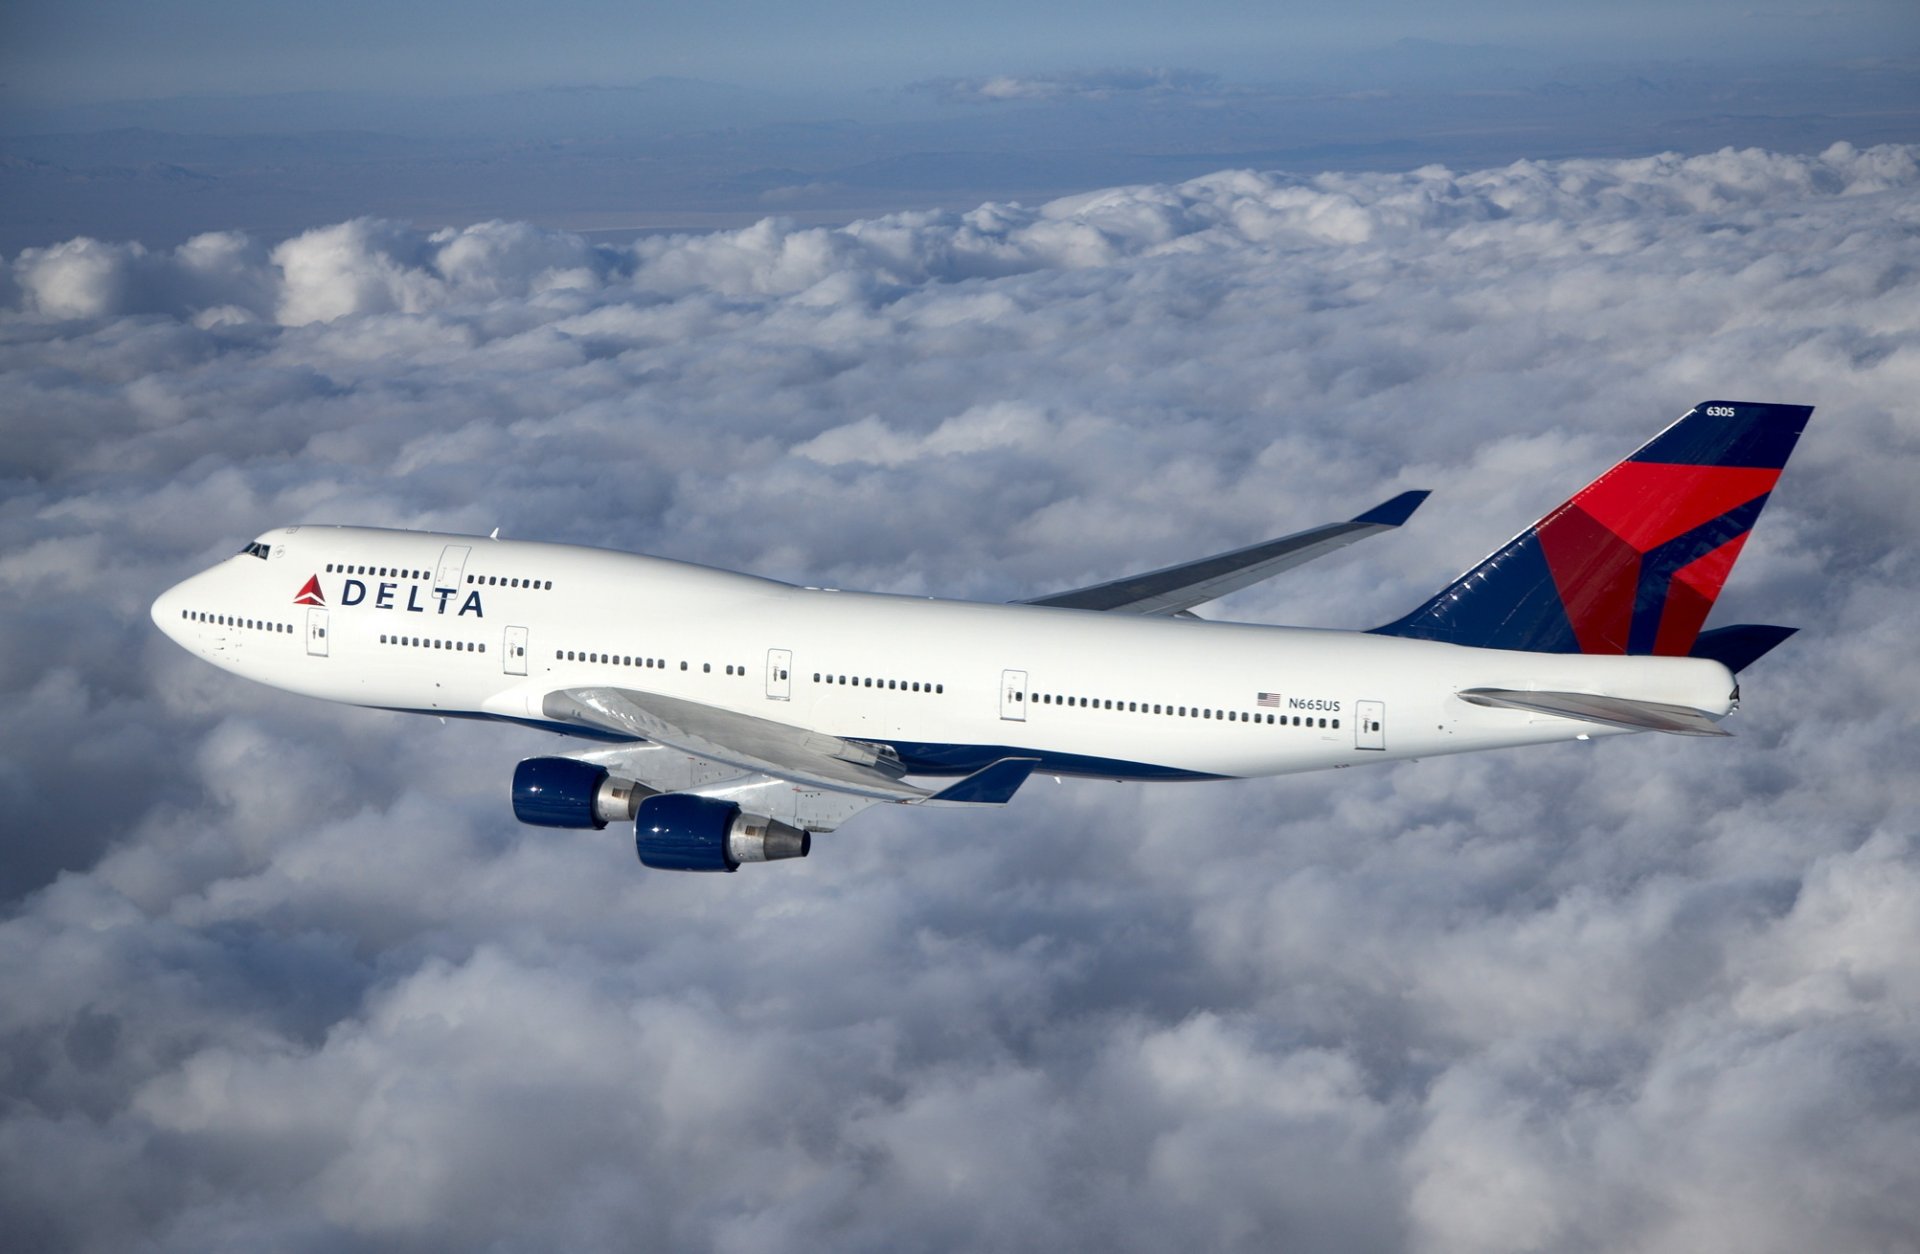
xmin=0 ymin=40 xmax=1920 ymax=255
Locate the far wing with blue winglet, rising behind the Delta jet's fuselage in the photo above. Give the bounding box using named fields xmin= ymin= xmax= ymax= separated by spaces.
xmin=1020 ymin=492 xmax=1427 ymax=615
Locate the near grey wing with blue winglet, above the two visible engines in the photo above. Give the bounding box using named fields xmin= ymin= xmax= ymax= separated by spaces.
xmin=541 ymin=687 xmax=1039 ymax=805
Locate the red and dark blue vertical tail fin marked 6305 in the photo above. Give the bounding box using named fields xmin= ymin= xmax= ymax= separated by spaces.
xmin=1375 ymin=401 xmax=1812 ymax=655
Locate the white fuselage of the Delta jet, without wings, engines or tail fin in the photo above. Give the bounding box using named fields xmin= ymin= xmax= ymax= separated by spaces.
xmin=154 ymin=526 xmax=1734 ymax=780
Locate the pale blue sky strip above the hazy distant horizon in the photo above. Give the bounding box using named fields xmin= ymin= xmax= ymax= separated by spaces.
xmin=0 ymin=0 xmax=1916 ymax=100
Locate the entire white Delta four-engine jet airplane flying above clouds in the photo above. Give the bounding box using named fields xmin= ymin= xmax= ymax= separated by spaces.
xmin=152 ymin=401 xmax=1812 ymax=872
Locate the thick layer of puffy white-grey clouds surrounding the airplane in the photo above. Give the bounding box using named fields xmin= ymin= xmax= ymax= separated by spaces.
xmin=0 ymin=146 xmax=1920 ymax=1252
